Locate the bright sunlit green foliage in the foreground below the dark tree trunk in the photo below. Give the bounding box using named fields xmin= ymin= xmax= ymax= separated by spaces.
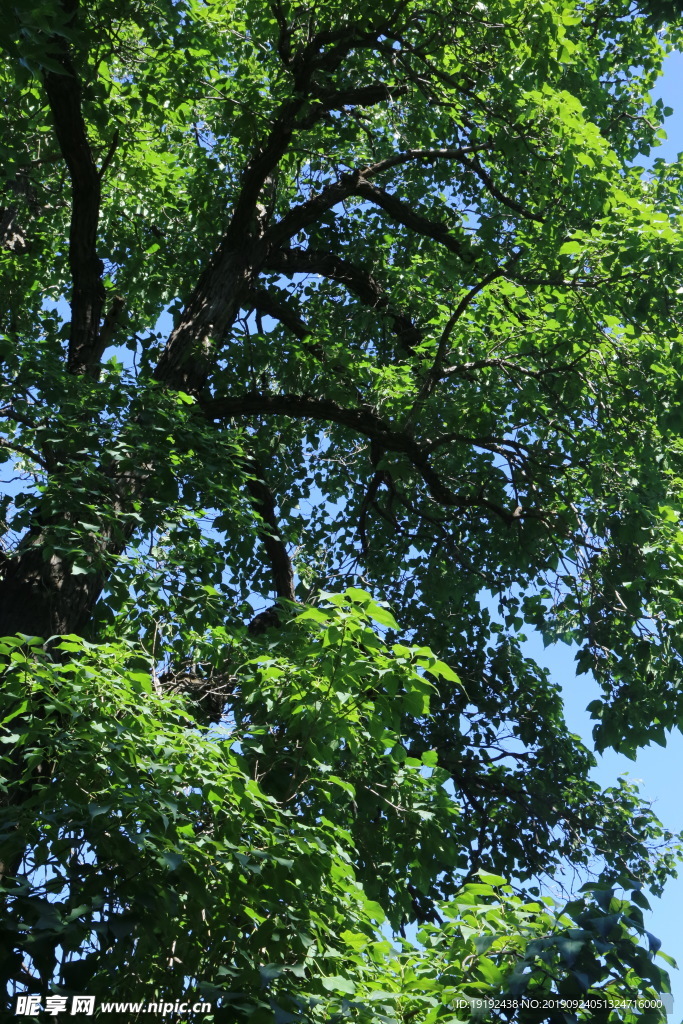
xmin=2 ymin=610 xmax=668 ymax=1024
